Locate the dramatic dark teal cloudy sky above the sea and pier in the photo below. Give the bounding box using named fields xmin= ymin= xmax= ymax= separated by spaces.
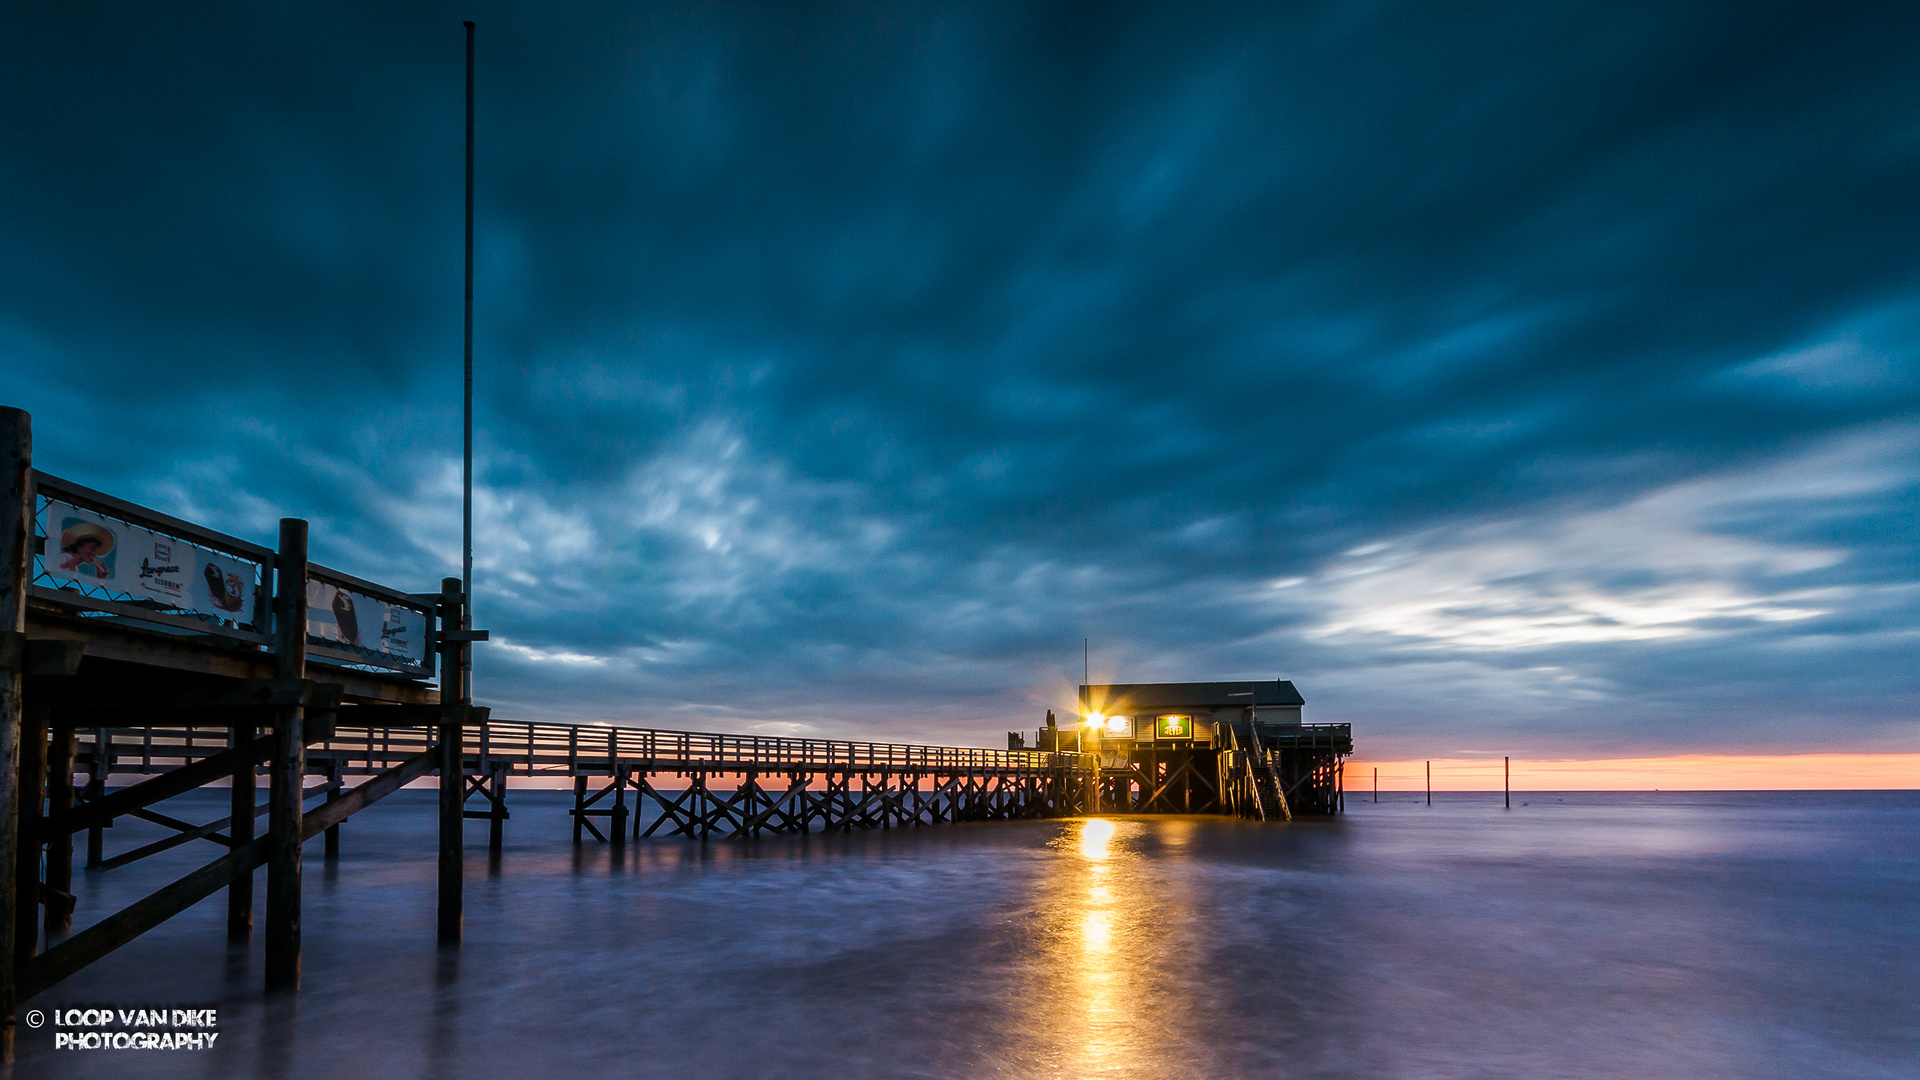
xmin=0 ymin=2 xmax=1920 ymax=759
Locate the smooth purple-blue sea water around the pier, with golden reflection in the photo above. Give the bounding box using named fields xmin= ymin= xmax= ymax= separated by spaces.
xmin=19 ymin=780 xmax=1920 ymax=1080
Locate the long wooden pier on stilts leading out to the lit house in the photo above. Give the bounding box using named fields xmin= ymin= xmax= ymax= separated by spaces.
xmin=0 ymin=409 xmax=1352 ymax=1059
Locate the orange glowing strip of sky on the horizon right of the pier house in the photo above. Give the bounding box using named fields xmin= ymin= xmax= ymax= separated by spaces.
xmin=1346 ymin=753 xmax=1920 ymax=796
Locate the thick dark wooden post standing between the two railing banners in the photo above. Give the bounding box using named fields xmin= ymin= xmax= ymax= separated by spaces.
xmin=264 ymin=517 xmax=307 ymax=990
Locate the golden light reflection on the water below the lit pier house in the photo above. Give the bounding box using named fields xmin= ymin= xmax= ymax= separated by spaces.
xmin=1031 ymin=817 xmax=1179 ymax=1076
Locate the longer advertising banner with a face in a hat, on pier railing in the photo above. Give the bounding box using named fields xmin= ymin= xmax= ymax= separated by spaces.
xmin=40 ymin=500 xmax=259 ymax=623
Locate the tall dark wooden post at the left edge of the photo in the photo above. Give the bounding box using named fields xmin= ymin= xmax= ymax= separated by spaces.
xmin=0 ymin=399 xmax=33 ymax=1061
